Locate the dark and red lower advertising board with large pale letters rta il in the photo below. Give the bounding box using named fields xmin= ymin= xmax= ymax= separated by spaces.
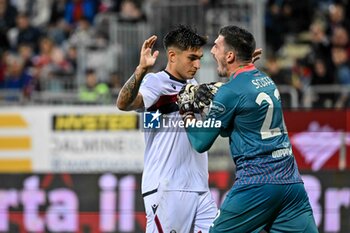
xmin=0 ymin=171 xmax=350 ymax=233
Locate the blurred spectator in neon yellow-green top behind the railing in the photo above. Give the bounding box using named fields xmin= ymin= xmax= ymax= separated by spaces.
xmin=79 ymin=70 xmax=110 ymax=104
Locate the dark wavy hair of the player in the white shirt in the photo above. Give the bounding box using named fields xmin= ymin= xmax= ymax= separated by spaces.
xmin=163 ymin=25 xmax=207 ymax=51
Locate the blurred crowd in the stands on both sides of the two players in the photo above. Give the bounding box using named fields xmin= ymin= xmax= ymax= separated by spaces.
xmin=0 ymin=0 xmax=350 ymax=108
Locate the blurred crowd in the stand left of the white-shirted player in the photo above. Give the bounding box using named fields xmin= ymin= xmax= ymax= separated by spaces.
xmin=0 ymin=0 xmax=146 ymax=102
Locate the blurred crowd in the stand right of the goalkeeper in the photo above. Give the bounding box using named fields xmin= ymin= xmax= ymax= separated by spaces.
xmin=265 ymin=0 xmax=350 ymax=108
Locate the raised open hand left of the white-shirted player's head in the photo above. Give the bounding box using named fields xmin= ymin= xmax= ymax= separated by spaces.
xmin=140 ymin=35 xmax=159 ymax=69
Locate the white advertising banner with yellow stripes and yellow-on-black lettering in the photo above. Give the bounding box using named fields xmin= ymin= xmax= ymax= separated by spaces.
xmin=0 ymin=106 xmax=144 ymax=173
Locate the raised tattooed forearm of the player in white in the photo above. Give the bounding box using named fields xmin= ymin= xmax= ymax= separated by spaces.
xmin=117 ymin=66 xmax=147 ymax=111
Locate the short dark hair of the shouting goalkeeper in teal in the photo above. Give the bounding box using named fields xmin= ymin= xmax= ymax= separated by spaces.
xmin=219 ymin=26 xmax=255 ymax=61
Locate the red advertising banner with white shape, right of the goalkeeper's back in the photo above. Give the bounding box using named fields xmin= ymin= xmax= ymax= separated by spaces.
xmin=284 ymin=110 xmax=350 ymax=171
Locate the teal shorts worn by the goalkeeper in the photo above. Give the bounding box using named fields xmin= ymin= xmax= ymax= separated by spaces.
xmin=209 ymin=183 xmax=318 ymax=233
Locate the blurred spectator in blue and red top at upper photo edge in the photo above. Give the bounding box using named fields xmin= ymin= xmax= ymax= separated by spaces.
xmin=64 ymin=0 xmax=97 ymax=27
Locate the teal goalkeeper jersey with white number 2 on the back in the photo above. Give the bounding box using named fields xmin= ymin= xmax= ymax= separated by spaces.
xmin=187 ymin=64 xmax=302 ymax=185
